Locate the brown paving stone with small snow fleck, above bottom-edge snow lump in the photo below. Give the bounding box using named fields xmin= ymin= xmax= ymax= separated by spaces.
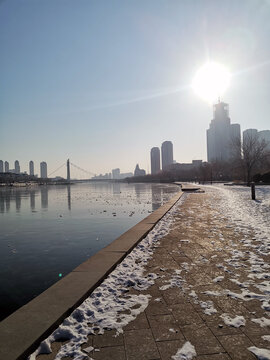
xmin=148 ymin=315 xmax=184 ymax=341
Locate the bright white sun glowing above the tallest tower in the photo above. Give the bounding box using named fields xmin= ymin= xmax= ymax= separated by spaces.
xmin=192 ymin=62 xmax=231 ymax=103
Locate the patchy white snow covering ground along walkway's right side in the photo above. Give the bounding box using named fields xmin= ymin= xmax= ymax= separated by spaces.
xmin=206 ymin=186 xmax=270 ymax=360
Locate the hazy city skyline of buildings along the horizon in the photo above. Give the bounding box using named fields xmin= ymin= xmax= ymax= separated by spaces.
xmin=0 ymin=101 xmax=270 ymax=180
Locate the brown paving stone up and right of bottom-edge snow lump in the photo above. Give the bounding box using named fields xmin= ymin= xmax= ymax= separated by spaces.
xmin=181 ymin=324 xmax=225 ymax=355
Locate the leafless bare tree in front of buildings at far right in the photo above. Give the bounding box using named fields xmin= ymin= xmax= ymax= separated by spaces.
xmin=232 ymin=133 xmax=270 ymax=185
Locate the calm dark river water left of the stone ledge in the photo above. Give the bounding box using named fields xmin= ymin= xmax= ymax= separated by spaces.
xmin=0 ymin=182 xmax=179 ymax=320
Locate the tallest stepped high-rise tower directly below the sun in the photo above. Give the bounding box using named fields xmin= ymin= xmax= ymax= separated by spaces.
xmin=207 ymin=102 xmax=241 ymax=162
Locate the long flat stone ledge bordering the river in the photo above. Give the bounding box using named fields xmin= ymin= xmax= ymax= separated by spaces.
xmin=0 ymin=191 xmax=183 ymax=360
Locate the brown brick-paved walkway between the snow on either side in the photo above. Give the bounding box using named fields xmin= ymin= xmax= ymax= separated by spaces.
xmin=37 ymin=192 xmax=270 ymax=360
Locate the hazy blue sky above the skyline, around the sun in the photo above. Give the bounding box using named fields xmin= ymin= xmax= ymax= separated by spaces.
xmin=0 ymin=0 xmax=270 ymax=177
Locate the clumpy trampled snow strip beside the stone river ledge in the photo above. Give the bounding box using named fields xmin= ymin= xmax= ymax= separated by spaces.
xmin=29 ymin=195 xmax=186 ymax=360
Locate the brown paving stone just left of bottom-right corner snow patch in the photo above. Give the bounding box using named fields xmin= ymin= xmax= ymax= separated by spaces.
xmin=218 ymin=334 xmax=256 ymax=360
